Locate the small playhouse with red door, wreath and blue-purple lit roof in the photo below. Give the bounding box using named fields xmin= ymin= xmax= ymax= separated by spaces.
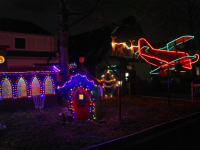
xmin=57 ymin=69 xmax=103 ymax=121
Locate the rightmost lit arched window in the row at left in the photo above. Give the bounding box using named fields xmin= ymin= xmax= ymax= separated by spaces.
xmin=43 ymin=75 xmax=55 ymax=95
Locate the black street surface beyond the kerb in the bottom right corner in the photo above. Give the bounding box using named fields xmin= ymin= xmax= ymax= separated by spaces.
xmin=129 ymin=118 xmax=200 ymax=150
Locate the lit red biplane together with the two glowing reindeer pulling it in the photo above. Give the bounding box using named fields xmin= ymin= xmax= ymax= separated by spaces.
xmin=111 ymin=35 xmax=199 ymax=77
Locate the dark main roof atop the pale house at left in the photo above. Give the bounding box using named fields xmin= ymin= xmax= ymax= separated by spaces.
xmin=0 ymin=18 xmax=53 ymax=35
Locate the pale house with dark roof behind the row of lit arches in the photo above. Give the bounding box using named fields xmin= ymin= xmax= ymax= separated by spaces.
xmin=0 ymin=18 xmax=59 ymax=67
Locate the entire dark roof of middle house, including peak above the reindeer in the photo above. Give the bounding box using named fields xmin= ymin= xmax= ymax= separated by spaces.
xmin=68 ymin=16 xmax=148 ymax=66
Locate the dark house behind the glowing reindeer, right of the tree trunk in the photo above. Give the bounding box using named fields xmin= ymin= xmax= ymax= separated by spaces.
xmin=69 ymin=16 xmax=151 ymax=95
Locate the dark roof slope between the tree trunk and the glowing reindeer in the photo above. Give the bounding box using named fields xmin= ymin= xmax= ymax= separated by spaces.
xmin=68 ymin=27 xmax=112 ymax=66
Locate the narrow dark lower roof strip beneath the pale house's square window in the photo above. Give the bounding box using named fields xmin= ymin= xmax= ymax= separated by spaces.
xmin=7 ymin=50 xmax=57 ymax=57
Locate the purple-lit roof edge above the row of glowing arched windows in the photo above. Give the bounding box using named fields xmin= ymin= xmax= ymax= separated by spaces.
xmin=0 ymin=66 xmax=60 ymax=75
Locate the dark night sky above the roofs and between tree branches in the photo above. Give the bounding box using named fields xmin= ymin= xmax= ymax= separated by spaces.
xmin=0 ymin=0 xmax=200 ymax=43
